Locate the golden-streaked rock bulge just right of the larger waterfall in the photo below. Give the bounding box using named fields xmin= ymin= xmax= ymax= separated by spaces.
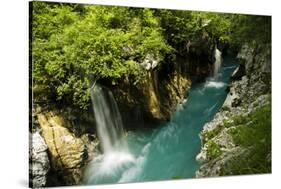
xmin=113 ymin=63 xmax=191 ymax=125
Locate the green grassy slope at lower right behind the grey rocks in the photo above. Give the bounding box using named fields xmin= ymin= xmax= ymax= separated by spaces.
xmin=223 ymin=104 xmax=271 ymax=175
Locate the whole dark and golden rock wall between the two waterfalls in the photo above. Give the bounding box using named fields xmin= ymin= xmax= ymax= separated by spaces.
xmin=110 ymin=36 xmax=215 ymax=128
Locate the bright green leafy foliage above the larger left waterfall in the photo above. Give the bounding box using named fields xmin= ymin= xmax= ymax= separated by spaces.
xmin=32 ymin=2 xmax=172 ymax=109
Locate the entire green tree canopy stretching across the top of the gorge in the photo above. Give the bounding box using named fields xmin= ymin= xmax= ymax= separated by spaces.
xmin=31 ymin=2 xmax=270 ymax=110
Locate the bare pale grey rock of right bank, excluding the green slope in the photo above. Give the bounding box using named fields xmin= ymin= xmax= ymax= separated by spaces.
xmin=196 ymin=45 xmax=271 ymax=177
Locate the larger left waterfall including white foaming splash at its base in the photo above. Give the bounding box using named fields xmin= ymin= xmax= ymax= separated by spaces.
xmin=85 ymin=85 xmax=135 ymax=184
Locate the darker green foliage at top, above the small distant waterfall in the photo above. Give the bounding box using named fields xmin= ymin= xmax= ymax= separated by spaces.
xmin=156 ymin=10 xmax=231 ymax=50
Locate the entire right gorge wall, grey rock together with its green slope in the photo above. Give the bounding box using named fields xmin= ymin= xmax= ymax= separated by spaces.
xmin=196 ymin=44 xmax=271 ymax=177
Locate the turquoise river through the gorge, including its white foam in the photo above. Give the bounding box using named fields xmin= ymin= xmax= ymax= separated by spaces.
xmin=83 ymin=52 xmax=237 ymax=184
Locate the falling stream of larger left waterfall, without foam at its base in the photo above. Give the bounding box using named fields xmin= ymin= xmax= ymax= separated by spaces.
xmin=91 ymin=85 xmax=127 ymax=154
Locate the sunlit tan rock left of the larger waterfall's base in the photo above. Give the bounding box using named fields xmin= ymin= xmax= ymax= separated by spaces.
xmin=34 ymin=111 xmax=95 ymax=185
